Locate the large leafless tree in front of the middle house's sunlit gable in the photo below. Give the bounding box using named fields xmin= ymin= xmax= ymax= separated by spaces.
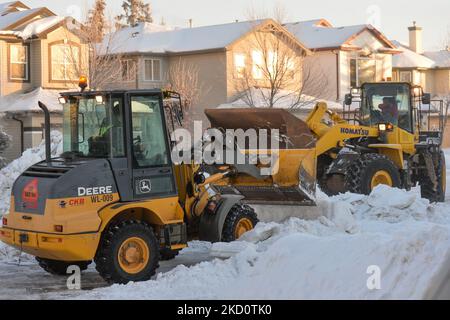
xmin=233 ymin=4 xmax=328 ymax=109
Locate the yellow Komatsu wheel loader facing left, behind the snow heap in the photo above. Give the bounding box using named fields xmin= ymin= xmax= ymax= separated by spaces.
xmin=306 ymin=82 xmax=448 ymax=202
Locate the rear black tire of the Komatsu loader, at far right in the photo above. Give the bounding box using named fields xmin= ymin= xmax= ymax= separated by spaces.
xmin=419 ymin=151 xmax=447 ymax=202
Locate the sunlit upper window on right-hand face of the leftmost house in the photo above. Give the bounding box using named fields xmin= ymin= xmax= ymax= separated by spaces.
xmin=50 ymin=43 xmax=80 ymax=81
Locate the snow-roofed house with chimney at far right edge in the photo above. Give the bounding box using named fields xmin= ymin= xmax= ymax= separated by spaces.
xmin=393 ymin=23 xmax=450 ymax=97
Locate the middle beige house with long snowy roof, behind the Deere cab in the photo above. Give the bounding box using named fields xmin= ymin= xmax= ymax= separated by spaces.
xmin=105 ymin=19 xmax=310 ymax=119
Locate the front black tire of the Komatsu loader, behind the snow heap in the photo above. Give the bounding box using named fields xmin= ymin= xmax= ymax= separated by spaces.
xmin=345 ymin=153 xmax=402 ymax=195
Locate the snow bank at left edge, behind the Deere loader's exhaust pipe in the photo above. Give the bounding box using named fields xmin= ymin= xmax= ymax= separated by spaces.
xmin=0 ymin=131 xmax=62 ymax=217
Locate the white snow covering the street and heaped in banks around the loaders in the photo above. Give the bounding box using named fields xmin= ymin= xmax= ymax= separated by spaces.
xmin=0 ymin=140 xmax=450 ymax=299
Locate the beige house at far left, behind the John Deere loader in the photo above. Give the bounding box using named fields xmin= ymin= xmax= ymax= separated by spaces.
xmin=0 ymin=1 xmax=88 ymax=160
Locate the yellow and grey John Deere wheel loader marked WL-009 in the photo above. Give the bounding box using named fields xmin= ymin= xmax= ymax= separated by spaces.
xmin=0 ymin=80 xmax=315 ymax=283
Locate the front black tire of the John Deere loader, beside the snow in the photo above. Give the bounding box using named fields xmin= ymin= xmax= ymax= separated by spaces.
xmin=222 ymin=204 xmax=259 ymax=242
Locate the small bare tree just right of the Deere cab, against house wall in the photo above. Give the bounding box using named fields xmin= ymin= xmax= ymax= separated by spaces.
xmin=167 ymin=58 xmax=205 ymax=124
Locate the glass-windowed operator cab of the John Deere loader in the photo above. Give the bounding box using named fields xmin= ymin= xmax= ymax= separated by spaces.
xmin=60 ymin=90 xmax=181 ymax=201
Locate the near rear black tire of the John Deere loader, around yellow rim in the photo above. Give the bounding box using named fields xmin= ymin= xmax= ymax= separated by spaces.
xmin=94 ymin=220 xmax=159 ymax=284
